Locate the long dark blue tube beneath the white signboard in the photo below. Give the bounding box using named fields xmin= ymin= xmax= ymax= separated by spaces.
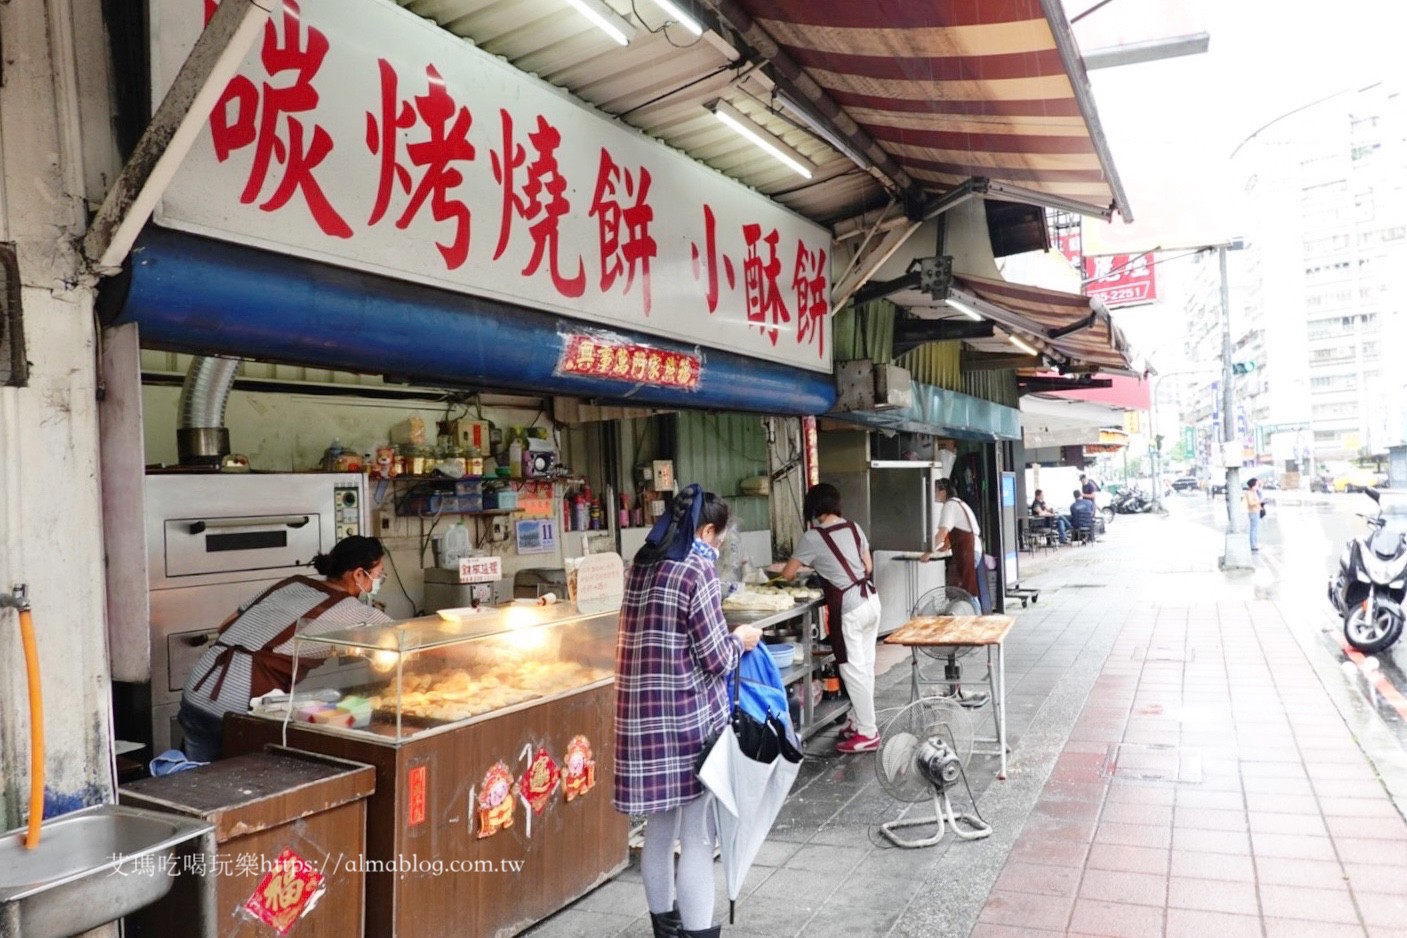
xmin=98 ymin=225 xmax=836 ymax=416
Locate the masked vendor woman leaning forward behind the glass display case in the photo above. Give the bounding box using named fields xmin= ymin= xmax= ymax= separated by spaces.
xmin=176 ymin=536 xmax=391 ymax=762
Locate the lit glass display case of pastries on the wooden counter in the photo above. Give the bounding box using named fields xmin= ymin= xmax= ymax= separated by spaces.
xmin=255 ymin=602 xmax=616 ymax=741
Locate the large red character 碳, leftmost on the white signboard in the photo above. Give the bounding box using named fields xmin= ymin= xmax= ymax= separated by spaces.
xmin=207 ymin=0 xmax=352 ymax=238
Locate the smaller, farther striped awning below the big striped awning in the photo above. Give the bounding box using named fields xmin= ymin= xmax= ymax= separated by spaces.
xmin=951 ymin=276 xmax=1133 ymax=373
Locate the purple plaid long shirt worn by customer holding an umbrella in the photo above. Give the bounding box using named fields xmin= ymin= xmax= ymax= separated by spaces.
xmin=611 ymin=541 xmax=743 ymax=814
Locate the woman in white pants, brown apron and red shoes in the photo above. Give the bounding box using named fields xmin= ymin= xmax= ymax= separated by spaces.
xmin=782 ymin=482 xmax=879 ymax=752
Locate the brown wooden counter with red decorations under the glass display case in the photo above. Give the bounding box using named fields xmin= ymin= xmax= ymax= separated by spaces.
xmin=225 ymin=682 xmax=628 ymax=938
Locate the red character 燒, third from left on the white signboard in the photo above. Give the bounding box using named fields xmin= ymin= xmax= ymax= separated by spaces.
xmin=492 ymin=110 xmax=587 ymax=298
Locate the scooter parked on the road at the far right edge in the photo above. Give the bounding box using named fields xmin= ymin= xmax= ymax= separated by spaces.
xmin=1328 ymin=488 xmax=1407 ymax=654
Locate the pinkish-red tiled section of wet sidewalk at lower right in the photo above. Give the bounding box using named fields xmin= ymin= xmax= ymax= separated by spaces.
xmin=972 ymin=600 xmax=1407 ymax=938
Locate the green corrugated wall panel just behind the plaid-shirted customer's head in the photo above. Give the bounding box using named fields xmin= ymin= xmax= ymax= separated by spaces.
xmin=674 ymin=412 xmax=771 ymax=530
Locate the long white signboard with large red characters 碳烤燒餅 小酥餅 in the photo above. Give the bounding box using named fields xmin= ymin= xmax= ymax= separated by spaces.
xmin=151 ymin=0 xmax=832 ymax=371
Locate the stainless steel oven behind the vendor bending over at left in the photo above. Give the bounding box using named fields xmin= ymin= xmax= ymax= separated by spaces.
xmin=146 ymin=471 xmax=367 ymax=752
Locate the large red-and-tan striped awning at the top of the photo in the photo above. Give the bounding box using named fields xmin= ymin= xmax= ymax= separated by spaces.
xmin=741 ymin=0 xmax=1131 ymax=219
